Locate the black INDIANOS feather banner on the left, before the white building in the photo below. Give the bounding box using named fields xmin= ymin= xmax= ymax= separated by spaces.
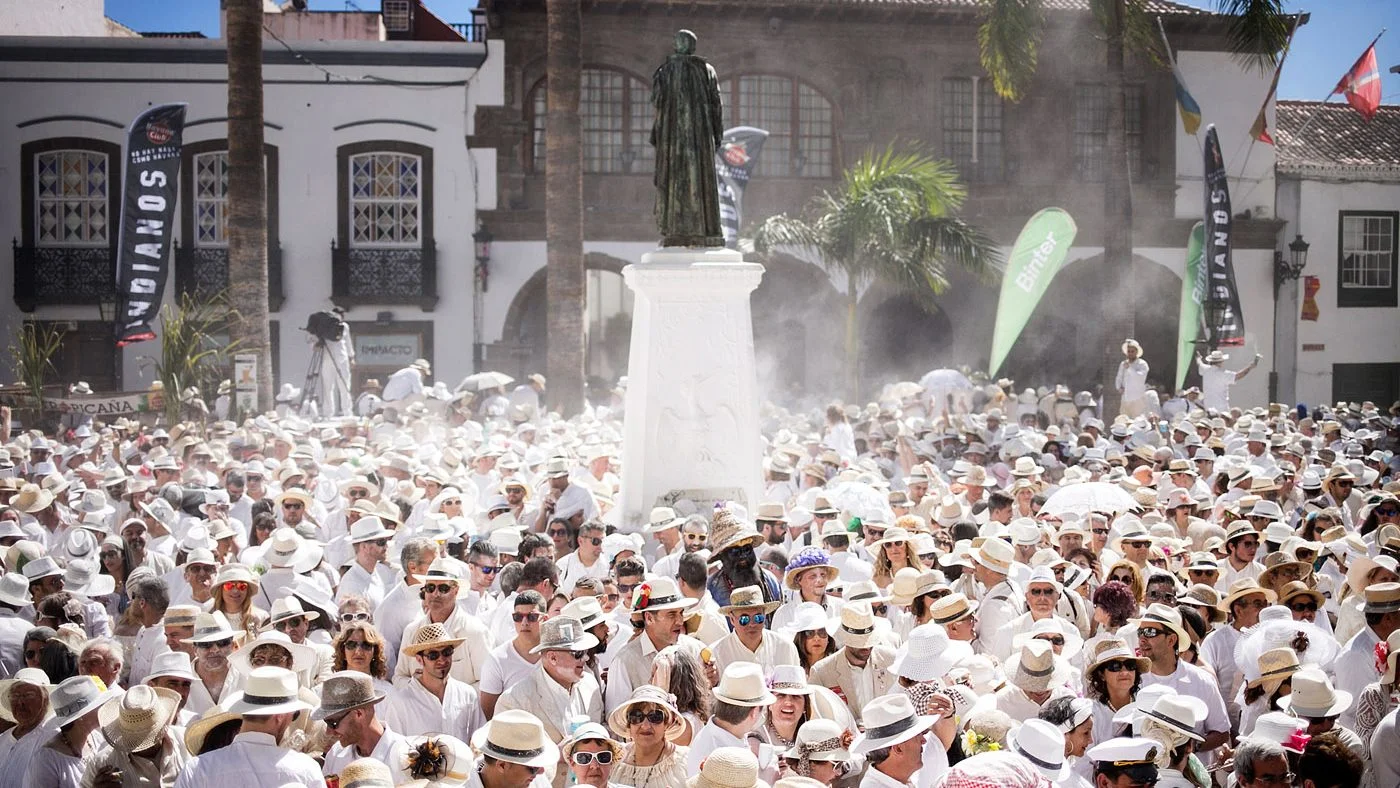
xmin=116 ymin=104 xmax=185 ymax=347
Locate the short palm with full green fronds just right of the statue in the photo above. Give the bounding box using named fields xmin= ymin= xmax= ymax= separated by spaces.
xmin=753 ymin=146 xmax=1001 ymax=402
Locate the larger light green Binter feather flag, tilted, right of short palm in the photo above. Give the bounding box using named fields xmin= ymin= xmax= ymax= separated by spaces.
xmin=987 ymin=209 xmax=1079 ymax=375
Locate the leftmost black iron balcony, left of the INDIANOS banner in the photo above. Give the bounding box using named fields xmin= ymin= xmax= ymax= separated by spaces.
xmin=11 ymin=241 xmax=116 ymax=312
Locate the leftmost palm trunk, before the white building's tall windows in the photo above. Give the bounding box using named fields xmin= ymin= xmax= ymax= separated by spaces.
xmin=224 ymin=0 xmax=273 ymax=411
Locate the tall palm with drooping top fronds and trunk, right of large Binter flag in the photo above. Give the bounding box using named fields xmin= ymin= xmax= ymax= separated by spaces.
xmin=977 ymin=0 xmax=1289 ymax=414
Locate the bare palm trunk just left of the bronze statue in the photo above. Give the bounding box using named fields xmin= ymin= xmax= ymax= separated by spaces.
xmin=545 ymin=0 xmax=587 ymax=416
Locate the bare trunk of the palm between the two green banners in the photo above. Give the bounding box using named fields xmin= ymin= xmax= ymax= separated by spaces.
xmin=1099 ymin=0 xmax=1137 ymax=418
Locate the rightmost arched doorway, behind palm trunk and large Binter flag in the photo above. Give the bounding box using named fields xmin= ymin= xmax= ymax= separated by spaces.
xmin=1000 ymin=255 xmax=1182 ymax=391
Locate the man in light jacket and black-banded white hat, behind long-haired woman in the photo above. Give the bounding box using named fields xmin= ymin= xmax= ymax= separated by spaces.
xmin=603 ymin=577 xmax=706 ymax=714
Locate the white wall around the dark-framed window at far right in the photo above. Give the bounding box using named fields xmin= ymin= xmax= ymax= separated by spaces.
xmin=1280 ymin=181 xmax=1400 ymax=407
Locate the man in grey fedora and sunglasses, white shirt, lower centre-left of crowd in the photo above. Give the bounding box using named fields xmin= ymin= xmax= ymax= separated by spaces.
xmin=496 ymin=614 xmax=603 ymax=743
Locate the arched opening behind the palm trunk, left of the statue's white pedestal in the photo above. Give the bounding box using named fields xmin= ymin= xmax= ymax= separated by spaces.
xmin=490 ymin=252 xmax=631 ymax=391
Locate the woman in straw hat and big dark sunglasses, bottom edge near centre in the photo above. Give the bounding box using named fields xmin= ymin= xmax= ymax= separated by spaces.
xmin=608 ymin=684 xmax=690 ymax=788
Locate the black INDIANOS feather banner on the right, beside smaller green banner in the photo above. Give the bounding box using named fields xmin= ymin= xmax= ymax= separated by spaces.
xmin=1204 ymin=125 xmax=1245 ymax=349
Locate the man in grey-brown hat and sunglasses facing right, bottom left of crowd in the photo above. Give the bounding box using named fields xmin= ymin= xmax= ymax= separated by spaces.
xmin=311 ymin=670 xmax=409 ymax=777
